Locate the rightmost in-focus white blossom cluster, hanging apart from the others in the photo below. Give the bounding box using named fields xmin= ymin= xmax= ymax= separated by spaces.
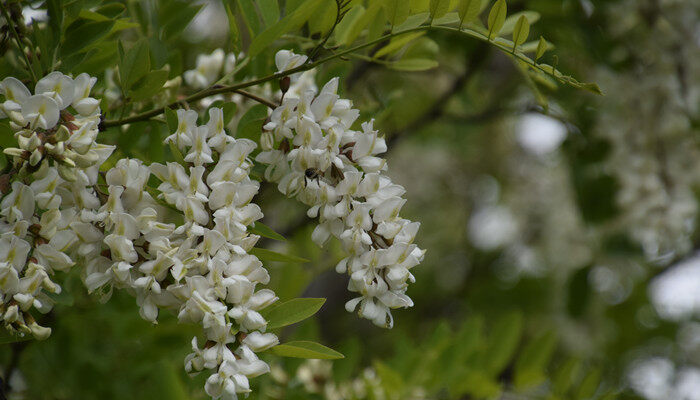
xmin=256 ymin=53 xmax=424 ymax=328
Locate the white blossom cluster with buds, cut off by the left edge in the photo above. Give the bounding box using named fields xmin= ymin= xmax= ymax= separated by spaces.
xmin=0 ymin=72 xmax=114 ymax=339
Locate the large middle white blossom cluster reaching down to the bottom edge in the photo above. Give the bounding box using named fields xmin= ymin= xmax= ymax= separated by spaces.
xmin=83 ymin=108 xmax=278 ymax=399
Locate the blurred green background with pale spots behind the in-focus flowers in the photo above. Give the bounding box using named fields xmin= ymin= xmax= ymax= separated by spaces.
xmin=0 ymin=0 xmax=700 ymax=400
